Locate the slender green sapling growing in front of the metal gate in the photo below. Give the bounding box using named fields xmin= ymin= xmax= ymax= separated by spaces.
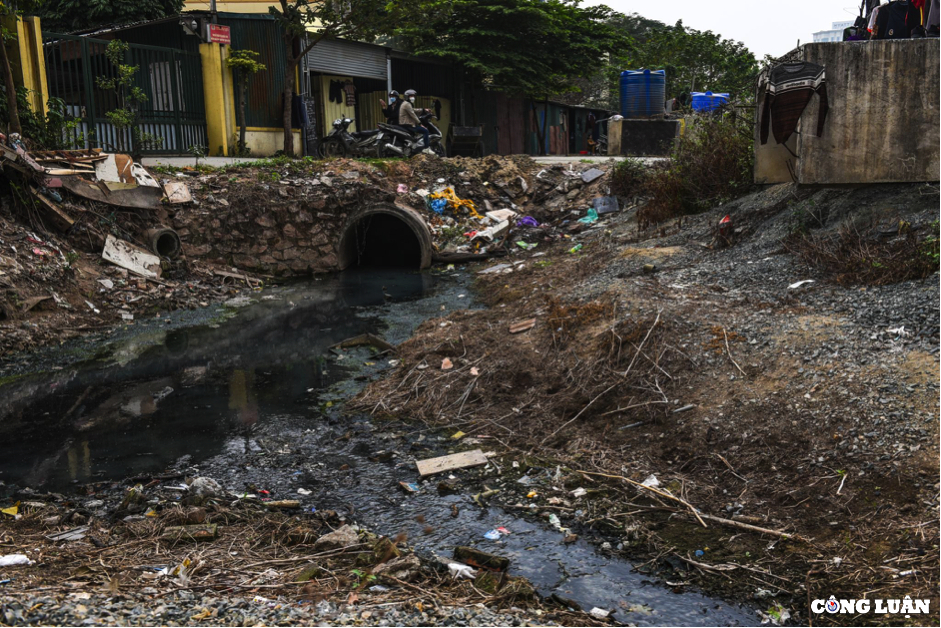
xmin=95 ymin=39 xmax=163 ymax=161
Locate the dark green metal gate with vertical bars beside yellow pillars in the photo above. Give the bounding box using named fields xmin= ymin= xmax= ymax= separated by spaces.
xmin=43 ymin=33 xmax=210 ymax=155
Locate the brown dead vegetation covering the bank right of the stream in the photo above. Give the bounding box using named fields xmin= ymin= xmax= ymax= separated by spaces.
xmin=354 ymin=216 xmax=938 ymax=624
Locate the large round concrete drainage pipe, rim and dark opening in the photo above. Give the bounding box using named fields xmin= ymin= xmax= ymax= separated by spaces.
xmin=337 ymin=204 xmax=433 ymax=270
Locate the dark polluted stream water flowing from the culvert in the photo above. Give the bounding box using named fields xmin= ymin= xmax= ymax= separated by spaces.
xmin=0 ymin=271 xmax=757 ymax=626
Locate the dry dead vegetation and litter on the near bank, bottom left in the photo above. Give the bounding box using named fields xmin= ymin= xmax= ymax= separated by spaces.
xmin=0 ymin=499 xmax=598 ymax=625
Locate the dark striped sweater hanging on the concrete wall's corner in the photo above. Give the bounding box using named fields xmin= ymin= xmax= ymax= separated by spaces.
xmin=759 ymin=61 xmax=830 ymax=144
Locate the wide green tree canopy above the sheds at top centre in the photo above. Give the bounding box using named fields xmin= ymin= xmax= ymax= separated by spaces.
xmin=396 ymin=0 xmax=630 ymax=150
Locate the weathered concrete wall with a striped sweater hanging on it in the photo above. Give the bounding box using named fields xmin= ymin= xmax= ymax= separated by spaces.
xmin=755 ymin=39 xmax=941 ymax=184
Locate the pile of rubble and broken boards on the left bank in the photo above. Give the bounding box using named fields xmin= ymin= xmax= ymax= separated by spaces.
xmin=0 ymin=135 xmax=260 ymax=356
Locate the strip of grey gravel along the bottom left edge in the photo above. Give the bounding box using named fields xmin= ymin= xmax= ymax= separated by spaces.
xmin=0 ymin=590 xmax=553 ymax=626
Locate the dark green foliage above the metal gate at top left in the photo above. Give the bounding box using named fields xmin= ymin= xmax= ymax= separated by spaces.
xmin=37 ymin=0 xmax=185 ymax=32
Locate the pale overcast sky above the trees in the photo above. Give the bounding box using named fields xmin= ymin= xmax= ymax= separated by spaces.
xmin=585 ymin=0 xmax=860 ymax=59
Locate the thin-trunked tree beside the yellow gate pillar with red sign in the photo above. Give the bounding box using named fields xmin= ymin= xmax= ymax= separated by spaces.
xmin=268 ymin=0 xmax=390 ymax=156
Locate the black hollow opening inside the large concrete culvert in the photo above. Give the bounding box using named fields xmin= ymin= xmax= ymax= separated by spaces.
xmin=341 ymin=213 xmax=422 ymax=268
